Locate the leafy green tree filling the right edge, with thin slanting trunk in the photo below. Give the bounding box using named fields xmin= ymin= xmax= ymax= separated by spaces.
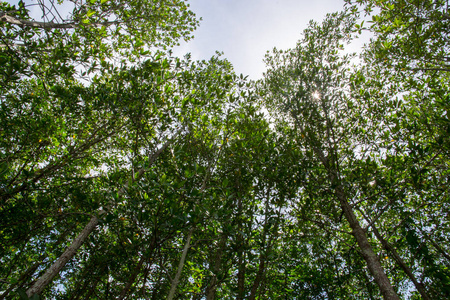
xmin=349 ymin=1 xmax=450 ymax=299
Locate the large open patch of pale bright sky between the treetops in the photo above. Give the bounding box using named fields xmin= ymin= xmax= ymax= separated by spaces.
xmin=174 ymin=0 xmax=344 ymax=79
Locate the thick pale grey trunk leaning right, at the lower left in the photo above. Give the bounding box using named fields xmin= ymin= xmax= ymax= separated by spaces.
xmin=27 ymin=216 xmax=98 ymax=297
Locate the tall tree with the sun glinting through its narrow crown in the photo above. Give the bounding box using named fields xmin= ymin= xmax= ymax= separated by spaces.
xmin=261 ymin=10 xmax=398 ymax=299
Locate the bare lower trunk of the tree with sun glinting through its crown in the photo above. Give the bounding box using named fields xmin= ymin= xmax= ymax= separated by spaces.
xmin=331 ymin=183 xmax=400 ymax=300
